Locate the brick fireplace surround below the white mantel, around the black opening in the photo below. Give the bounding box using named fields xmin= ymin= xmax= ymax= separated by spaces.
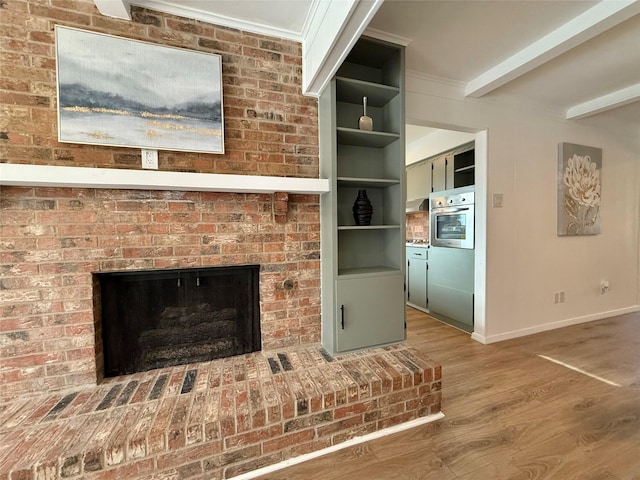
xmin=0 ymin=187 xmax=320 ymax=399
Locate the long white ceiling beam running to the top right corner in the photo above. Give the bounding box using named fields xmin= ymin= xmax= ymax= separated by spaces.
xmin=464 ymin=0 xmax=640 ymax=97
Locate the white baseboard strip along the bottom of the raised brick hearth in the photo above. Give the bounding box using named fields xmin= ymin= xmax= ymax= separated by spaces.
xmin=229 ymin=412 xmax=444 ymax=480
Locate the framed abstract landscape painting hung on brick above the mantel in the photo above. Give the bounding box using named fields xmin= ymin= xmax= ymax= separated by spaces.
xmin=56 ymin=26 xmax=224 ymax=153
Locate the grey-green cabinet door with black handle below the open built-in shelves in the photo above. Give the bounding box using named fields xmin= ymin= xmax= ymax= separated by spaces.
xmin=335 ymin=273 xmax=405 ymax=352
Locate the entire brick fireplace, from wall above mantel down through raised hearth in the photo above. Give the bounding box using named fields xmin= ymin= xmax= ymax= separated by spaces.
xmin=0 ymin=0 xmax=440 ymax=480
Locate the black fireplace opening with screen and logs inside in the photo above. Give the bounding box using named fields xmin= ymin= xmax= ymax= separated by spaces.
xmin=96 ymin=265 xmax=261 ymax=377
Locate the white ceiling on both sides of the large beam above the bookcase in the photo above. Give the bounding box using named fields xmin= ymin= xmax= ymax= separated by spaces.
xmin=105 ymin=0 xmax=640 ymax=132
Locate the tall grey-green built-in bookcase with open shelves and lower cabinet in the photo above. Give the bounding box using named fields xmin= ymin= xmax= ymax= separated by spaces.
xmin=319 ymin=38 xmax=406 ymax=353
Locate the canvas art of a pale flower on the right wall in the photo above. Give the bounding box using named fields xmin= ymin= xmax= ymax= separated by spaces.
xmin=558 ymin=143 xmax=602 ymax=236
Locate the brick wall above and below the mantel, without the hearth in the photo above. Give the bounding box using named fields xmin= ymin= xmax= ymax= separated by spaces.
xmin=0 ymin=0 xmax=320 ymax=399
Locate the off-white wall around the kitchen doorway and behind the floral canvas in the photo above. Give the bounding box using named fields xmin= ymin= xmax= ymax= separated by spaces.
xmin=406 ymin=76 xmax=640 ymax=342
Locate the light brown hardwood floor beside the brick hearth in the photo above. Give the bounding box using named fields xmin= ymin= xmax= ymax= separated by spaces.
xmin=252 ymin=308 xmax=640 ymax=480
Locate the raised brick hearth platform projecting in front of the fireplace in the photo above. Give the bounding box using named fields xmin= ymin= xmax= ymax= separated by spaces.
xmin=0 ymin=345 xmax=441 ymax=480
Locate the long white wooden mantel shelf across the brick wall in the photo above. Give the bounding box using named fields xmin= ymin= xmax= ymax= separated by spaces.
xmin=0 ymin=163 xmax=329 ymax=194
